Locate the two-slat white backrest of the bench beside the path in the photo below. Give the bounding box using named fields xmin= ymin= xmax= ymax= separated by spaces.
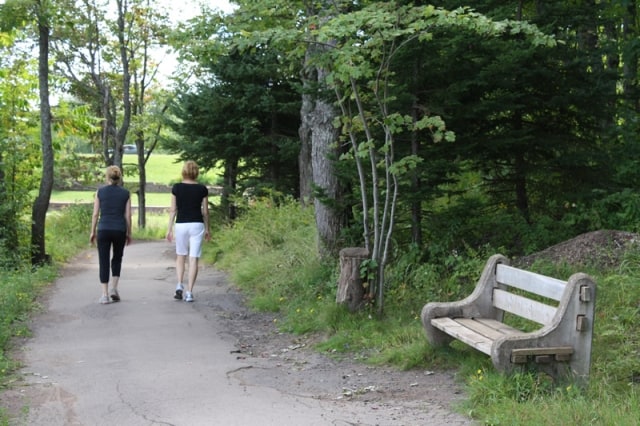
xmin=493 ymin=263 xmax=567 ymax=325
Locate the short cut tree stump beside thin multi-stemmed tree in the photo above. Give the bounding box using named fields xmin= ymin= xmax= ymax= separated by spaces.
xmin=336 ymin=247 xmax=369 ymax=312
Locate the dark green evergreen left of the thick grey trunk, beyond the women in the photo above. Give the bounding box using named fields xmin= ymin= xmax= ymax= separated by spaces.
xmin=165 ymin=45 xmax=300 ymax=218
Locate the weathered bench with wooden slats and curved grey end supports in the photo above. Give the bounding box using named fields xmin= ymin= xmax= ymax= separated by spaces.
xmin=422 ymin=254 xmax=596 ymax=385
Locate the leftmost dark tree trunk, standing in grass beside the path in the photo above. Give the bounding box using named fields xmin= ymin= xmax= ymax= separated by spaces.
xmin=31 ymin=13 xmax=53 ymax=265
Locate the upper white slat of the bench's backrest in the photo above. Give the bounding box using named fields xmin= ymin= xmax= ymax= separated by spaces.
xmin=496 ymin=264 xmax=567 ymax=302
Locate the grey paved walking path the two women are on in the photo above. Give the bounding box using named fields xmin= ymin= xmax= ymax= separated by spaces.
xmin=0 ymin=241 xmax=476 ymax=426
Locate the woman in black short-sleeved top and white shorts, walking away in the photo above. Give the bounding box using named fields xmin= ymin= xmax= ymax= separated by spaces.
xmin=167 ymin=161 xmax=211 ymax=302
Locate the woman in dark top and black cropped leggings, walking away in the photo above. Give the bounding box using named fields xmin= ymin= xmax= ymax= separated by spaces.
xmin=89 ymin=166 xmax=131 ymax=304
